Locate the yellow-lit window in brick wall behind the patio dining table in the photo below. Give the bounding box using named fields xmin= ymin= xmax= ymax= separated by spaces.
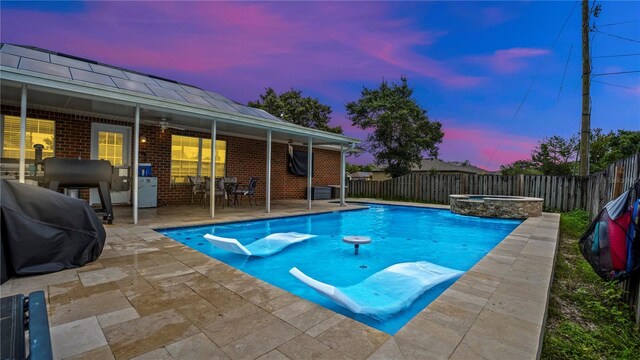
xmin=171 ymin=135 xmax=227 ymax=183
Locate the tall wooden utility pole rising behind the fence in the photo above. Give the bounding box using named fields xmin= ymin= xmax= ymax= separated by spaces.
xmin=580 ymin=0 xmax=591 ymax=176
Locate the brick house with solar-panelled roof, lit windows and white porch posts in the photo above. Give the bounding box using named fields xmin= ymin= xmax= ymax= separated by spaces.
xmin=0 ymin=44 xmax=359 ymax=223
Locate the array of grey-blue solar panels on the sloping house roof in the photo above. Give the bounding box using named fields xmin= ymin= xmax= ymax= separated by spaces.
xmin=0 ymin=43 xmax=286 ymax=123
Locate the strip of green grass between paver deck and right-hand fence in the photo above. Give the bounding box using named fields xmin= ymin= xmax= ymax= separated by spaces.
xmin=541 ymin=210 xmax=640 ymax=359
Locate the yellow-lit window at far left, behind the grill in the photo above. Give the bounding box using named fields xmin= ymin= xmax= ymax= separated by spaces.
xmin=2 ymin=116 xmax=55 ymax=161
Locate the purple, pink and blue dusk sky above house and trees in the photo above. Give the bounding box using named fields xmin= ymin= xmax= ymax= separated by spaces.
xmin=0 ymin=0 xmax=640 ymax=170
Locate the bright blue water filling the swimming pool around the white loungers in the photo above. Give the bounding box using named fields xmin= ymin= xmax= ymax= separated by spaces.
xmin=160 ymin=205 xmax=522 ymax=335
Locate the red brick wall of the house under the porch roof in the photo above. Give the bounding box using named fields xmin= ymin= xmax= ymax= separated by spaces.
xmin=1 ymin=106 xmax=340 ymax=206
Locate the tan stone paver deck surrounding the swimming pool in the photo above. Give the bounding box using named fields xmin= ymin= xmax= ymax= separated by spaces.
xmin=0 ymin=199 xmax=559 ymax=359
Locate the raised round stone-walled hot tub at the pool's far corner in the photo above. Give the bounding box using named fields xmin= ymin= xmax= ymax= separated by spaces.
xmin=449 ymin=195 xmax=543 ymax=219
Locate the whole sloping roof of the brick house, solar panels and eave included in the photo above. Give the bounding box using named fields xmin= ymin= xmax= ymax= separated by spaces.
xmin=0 ymin=43 xmax=360 ymax=143
